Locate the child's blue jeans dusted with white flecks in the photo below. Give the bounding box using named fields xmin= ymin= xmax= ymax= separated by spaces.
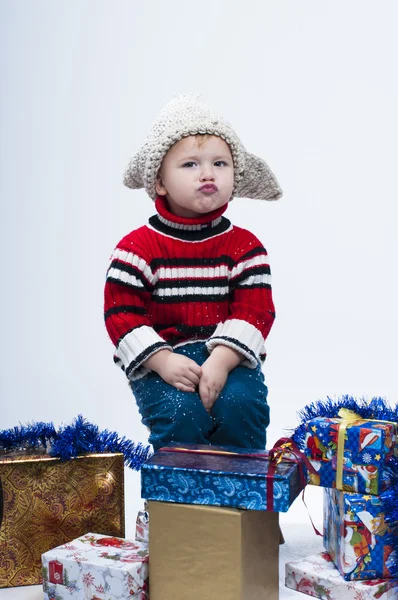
xmin=130 ymin=342 xmax=269 ymax=450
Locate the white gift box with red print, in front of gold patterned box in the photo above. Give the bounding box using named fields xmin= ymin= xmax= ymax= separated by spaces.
xmin=42 ymin=533 xmax=148 ymax=600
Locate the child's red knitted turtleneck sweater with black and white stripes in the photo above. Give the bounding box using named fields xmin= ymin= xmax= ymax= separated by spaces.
xmin=105 ymin=197 xmax=275 ymax=379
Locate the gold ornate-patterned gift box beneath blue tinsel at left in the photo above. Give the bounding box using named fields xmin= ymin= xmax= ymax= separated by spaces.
xmin=0 ymin=453 xmax=124 ymax=588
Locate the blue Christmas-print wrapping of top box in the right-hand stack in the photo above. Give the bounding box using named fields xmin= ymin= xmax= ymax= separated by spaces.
xmin=304 ymin=417 xmax=398 ymax=495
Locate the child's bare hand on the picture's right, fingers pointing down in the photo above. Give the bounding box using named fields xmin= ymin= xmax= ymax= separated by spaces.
xmin=199 ymin=344 xmax=244 ymax=413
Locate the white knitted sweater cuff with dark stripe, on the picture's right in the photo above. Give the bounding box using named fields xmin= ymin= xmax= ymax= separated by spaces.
xmin=206 ymin=319 xmax=264 ymax=369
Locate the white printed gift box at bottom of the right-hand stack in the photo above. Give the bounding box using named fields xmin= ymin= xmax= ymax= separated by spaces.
xmin=285 ymin=552 xmax=398 ymax=600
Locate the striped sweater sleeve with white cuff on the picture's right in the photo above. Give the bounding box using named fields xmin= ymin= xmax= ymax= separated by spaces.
xmin=206 ymin=238 xmax=275 ymax=369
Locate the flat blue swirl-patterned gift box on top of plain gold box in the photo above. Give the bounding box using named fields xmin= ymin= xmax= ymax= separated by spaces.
xmin=141 ymin=445 xmax=307 ymax=512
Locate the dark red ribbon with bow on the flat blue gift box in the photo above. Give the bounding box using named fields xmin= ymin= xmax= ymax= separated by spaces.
xmin=159 ymin=438 xmax=316 ymax=511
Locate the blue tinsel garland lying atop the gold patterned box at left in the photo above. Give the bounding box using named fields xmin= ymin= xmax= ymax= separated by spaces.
xmin=0 ymin=415 xmax=151 ymax=471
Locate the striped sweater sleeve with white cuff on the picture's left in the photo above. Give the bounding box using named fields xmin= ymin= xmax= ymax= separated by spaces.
xmin=104 ymin=245 xmax=172 ymax=379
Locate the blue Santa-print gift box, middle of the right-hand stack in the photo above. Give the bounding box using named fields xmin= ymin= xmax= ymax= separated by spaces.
xmin=323 ymin=489 xmax=398 ymax=581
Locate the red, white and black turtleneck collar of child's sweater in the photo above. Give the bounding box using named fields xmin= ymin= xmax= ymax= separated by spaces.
xmin=149 ymin=196 xmax=231 ymax=241
